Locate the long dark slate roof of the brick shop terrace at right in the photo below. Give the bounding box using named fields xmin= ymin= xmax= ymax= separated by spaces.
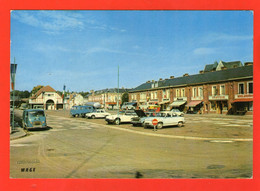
xmin=129 ymin=65 xmax=253 ymax=92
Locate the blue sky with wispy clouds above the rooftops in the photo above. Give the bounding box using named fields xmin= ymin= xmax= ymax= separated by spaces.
xmin=10 ymin=10 xmax=253 ymax=91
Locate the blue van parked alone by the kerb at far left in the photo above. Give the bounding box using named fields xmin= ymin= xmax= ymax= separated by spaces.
xmin=22 ymin=109 xmax=47 ymax=129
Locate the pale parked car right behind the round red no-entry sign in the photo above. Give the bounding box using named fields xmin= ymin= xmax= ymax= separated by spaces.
xmin=141 ymin=111 xmax=185 ymax=129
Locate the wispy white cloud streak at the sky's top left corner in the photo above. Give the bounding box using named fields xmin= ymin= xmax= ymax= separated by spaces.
xmin=11 ymin=11 xmax=126 ymax=35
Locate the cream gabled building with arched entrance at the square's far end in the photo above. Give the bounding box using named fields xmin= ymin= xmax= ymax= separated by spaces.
xmin=29 ymin=86 xmax=63 ymax=110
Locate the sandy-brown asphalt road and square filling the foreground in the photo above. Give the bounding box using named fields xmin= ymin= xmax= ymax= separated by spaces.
xmin=10 ymin=110 xmax=253 ymax=178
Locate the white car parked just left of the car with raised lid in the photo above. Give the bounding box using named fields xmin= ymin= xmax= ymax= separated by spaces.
xmin=105 ymin=110 xmax=137 ymax=125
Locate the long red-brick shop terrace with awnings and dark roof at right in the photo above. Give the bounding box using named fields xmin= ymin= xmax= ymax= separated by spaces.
xmin=129 ymin=61 xmax=253 ymax=114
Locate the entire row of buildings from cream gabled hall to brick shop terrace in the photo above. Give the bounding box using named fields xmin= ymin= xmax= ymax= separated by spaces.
xmin=25 ymin=61 xmax=253 ymax=114
